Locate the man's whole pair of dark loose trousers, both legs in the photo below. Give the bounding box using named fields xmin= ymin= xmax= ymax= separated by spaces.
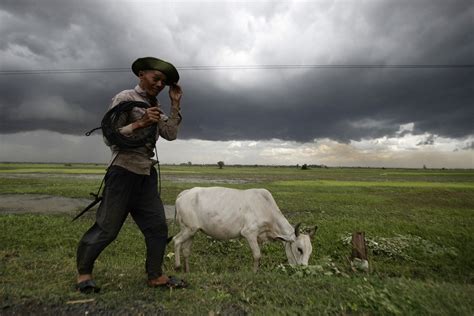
xmin=77 ymin=166 xmax=168 ymax=279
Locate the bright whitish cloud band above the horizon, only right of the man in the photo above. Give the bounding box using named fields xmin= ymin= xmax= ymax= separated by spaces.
xmin=158 ymin=135 xmax=474 ymax=168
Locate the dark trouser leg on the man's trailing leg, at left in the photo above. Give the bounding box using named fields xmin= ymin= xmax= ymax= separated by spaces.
xmin=77 ymin=166 xmax=135 ymax=274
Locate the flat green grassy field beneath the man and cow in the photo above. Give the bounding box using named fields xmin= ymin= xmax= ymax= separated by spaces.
xmin=0 ymin=163 xmax=474 ymax=315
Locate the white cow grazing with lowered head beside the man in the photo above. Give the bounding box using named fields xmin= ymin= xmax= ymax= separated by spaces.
xmin=173 ymin=187 xmax=317 ymax=272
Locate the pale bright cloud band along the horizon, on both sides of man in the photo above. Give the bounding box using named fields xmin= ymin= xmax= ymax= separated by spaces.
xmin=0 ymin=131 xmax=474 ymax=168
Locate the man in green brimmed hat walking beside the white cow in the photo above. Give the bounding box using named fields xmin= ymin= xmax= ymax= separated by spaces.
xmin=76 ymin=57 xmax=184 ymax=293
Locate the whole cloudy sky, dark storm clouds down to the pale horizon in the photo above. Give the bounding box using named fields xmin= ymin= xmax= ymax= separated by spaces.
xmin=0 ymin=0 xmax=474 ymax=168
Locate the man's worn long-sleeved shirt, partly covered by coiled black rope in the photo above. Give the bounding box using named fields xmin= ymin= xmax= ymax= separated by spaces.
xmin=104 ymin=85 xmax=181 ymax=175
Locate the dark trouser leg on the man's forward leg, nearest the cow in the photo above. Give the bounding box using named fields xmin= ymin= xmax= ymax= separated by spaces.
xmin=131 ymin=168 xmax=168 ymax=279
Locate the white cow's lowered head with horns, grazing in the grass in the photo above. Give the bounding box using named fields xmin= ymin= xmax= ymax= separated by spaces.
xmin=285 ymin=223 xmax=318 ymax=266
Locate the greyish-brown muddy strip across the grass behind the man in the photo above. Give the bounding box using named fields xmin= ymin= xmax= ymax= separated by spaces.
xmin=0 ymin=194 xmax=174 ymax=219
